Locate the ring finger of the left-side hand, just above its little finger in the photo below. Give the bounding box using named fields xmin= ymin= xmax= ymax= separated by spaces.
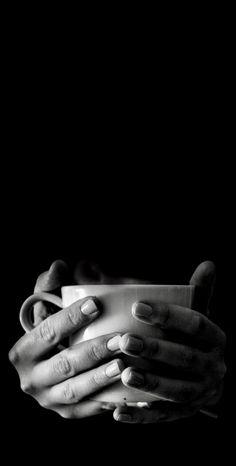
xmin=46 ymin=359 xmax=124 ymax=406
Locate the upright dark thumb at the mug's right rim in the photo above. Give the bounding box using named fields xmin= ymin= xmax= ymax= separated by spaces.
xmin=190 ymin=261 xmax=216 ymax=315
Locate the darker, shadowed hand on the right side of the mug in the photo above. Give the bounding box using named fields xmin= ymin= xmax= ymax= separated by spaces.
xmin=114 ymin=262 xmax=226 ymax=423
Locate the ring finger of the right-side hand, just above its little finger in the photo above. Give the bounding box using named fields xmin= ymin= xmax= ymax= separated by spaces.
xmin=121 ymin=367 xmax=206 ymax=403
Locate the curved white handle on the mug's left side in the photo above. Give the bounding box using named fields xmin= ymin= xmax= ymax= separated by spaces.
xmin=19 ymin=291 xmax=63 ymax=333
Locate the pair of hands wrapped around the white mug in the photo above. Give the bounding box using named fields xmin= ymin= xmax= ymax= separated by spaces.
xmin=9 ymin=261 xmax=226 ymax=423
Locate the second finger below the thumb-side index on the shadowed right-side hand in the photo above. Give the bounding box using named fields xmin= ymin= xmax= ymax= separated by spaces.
xmin=119 ymin=333 xmax=209 ymax=376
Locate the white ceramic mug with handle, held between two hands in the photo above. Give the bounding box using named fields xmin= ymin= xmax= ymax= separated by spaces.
xmin=20 ymin=284 xmax=195 ymax=404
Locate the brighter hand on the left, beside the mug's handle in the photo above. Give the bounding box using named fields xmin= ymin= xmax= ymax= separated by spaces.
xmin=9 ymin=261 xmax=124 ymax=418
